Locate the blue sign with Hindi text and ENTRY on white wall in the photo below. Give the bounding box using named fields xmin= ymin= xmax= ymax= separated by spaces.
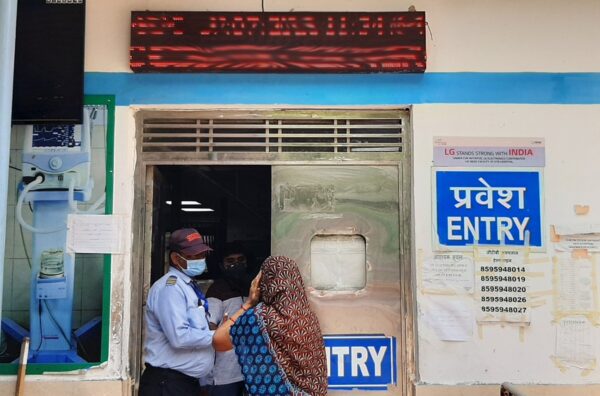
xmin=433 ymin=168 xmax=544 ymax=249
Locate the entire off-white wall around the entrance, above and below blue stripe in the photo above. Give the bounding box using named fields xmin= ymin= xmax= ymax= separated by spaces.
xmin=71 ymin=0 xmax=600 ymax=384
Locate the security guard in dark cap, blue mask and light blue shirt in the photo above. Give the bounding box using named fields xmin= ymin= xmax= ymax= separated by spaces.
xmin=139 ymin=228 xmax=215 ymax=396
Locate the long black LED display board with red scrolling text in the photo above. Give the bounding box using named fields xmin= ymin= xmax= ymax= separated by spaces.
xmin=130 ymin=11 xmax=426 ymax=73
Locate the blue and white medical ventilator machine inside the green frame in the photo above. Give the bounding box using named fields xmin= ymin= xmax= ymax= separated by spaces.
xmin=8 ymin=107 xmax=104 ymax=363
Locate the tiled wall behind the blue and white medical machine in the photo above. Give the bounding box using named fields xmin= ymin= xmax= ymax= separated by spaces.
xmin=2 ymin=106 xmax=106 ymax=329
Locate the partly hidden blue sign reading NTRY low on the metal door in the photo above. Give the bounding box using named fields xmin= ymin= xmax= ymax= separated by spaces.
xmin=323 ymin=334 xmax=397 ymax=390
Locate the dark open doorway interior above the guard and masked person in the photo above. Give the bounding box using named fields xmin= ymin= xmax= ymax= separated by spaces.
xmin=149 ymin=165 xmax=271 ymax=287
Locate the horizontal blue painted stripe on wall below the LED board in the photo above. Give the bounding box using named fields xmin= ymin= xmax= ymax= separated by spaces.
xmin=85 ymin=72 xmax=600 ymax=106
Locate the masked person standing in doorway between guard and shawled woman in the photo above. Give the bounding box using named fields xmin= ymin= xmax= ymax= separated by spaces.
xmin=206 ymin=242 xmax=252 ymax=396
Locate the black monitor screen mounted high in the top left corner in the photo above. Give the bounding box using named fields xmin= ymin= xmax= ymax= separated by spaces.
xmin=12 ymin=0 xmax=85 ymax=124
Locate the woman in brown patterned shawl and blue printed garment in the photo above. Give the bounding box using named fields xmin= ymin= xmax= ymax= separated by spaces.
xmin=213 ymin=256 xmax=327 ymax=396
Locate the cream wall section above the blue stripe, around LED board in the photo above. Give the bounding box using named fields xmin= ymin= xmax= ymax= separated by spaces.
xmin=85 ymin=0 xmax=600 ymax=72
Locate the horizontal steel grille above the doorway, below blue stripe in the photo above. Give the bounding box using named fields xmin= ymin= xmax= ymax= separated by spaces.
xmin=141 ymin=109 xmax=408 ymax=153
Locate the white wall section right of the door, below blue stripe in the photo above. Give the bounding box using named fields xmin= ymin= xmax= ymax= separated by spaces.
xmin=413 ymin=105 xmax=600 ymax=384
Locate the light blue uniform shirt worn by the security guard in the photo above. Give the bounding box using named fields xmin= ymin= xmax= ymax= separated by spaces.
xmin=144 ymin=267 xmax=215 ymax=378
